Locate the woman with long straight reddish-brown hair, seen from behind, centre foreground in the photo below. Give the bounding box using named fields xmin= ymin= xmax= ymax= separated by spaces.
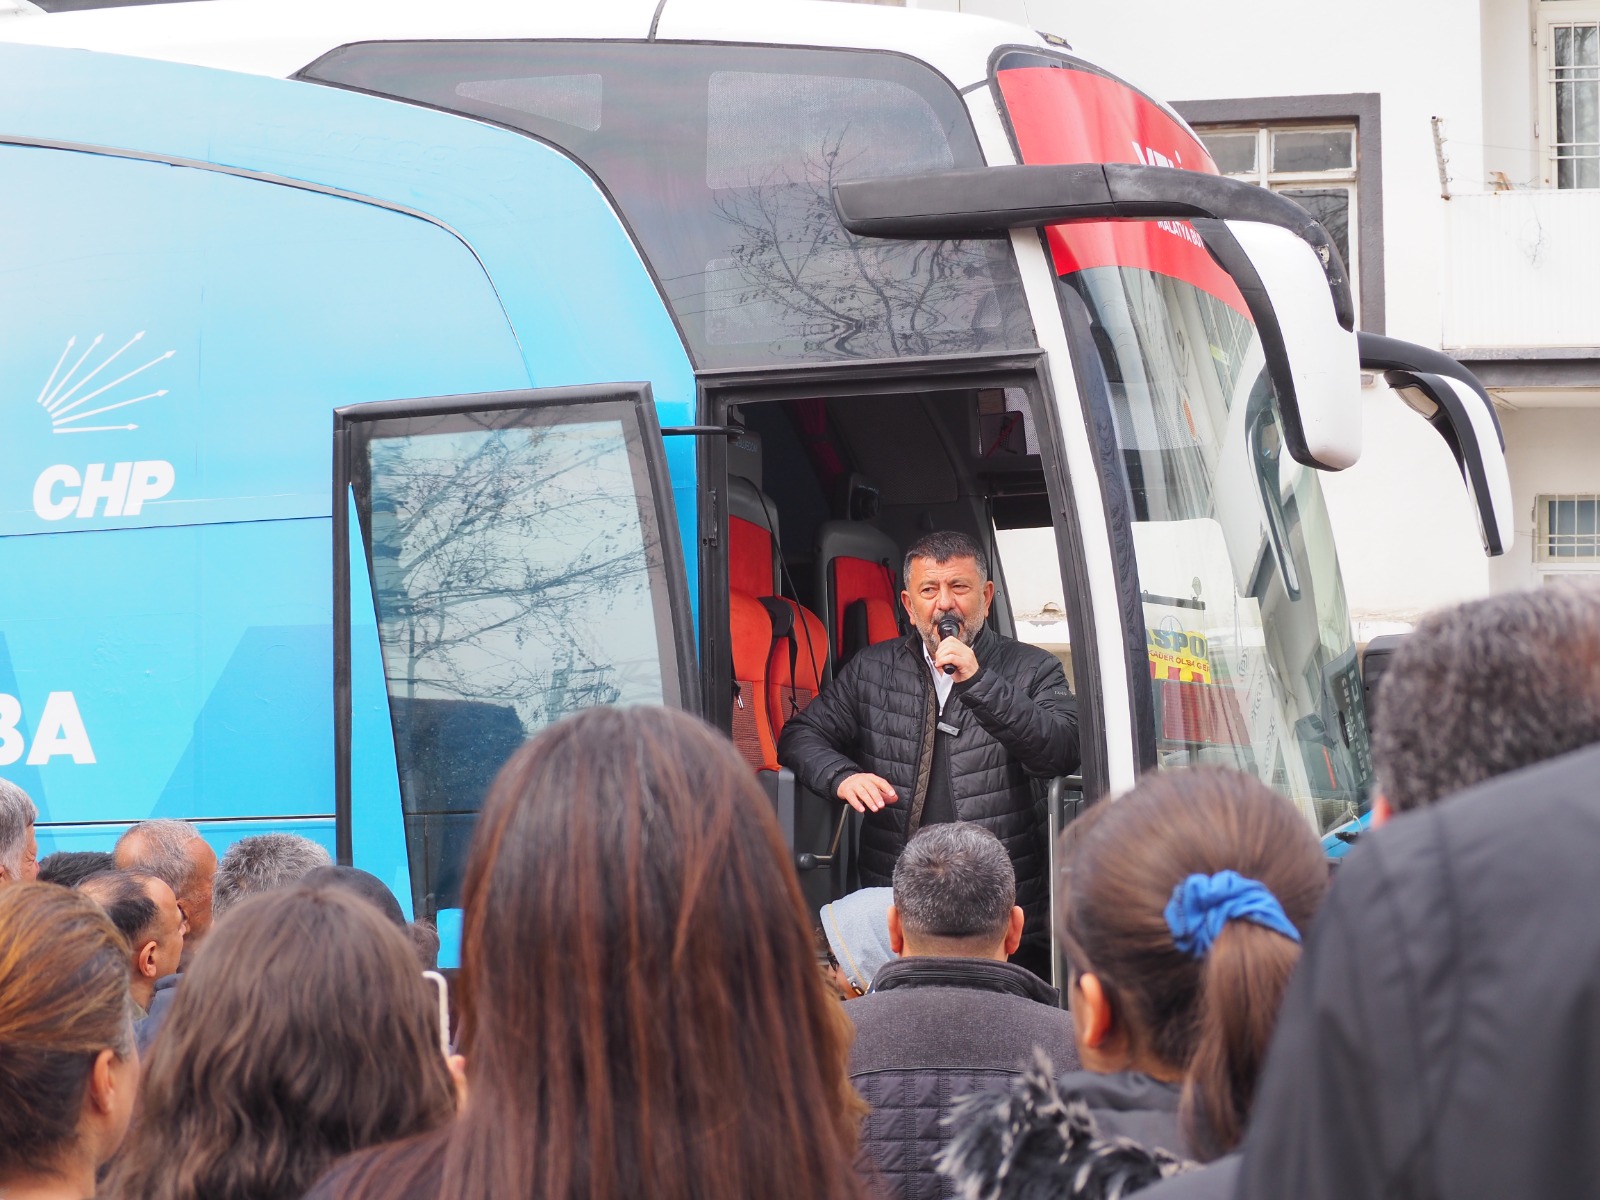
xmin=314 ymin=707 xmax=862 ymax=1200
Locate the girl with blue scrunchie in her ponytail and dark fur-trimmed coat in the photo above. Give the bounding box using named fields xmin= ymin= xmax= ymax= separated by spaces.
xmin=946 ymin=766 xmax=1328 ymax=1200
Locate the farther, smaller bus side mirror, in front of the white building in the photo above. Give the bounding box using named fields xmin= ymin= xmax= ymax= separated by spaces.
xmin=1358 ymin=333 xmax=1517 ymax=558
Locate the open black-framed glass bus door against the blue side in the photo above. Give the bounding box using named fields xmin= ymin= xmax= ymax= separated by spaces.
xmin=333 ymin=384 xmax=698 ymax=946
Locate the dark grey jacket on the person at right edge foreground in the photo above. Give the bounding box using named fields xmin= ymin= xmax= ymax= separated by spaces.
xmin=1238 ymin=746 xmax=1600 ymax=1200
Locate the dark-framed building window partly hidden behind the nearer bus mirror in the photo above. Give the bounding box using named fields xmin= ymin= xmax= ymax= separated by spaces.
xmin=1195 ymin=125 xmax=1360 ymax=305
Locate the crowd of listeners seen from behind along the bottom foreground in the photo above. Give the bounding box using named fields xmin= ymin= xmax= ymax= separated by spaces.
xmin=0 ymin=589 xmax=1600 ymax=1200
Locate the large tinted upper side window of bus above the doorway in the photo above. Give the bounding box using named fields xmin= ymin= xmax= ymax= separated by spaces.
xmin=301 ymin=42 xmax=1035 ymax=366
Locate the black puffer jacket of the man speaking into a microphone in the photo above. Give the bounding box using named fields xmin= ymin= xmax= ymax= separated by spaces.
xmin=778 ymin=627 xmax=1078 ymax=933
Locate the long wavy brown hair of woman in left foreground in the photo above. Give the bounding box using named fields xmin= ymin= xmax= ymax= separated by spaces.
xmin=106 ymin=885 xmax=456 ymax=1200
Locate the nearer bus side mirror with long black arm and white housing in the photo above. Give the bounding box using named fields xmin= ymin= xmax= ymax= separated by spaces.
xmin=834 ymin=163 xmax=1362 ymax=470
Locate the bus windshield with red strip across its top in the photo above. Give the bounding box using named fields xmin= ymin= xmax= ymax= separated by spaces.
xmin=997 ymin=54 xmax=1371 ymax=834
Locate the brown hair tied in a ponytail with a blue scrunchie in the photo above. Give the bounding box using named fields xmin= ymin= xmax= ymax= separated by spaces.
xmin=1056 ymin=766 xmax=1328 ymax=1158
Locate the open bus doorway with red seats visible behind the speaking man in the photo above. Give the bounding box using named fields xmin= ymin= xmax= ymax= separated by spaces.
xmin=701 ymin=378 xmax=1093 ymax=910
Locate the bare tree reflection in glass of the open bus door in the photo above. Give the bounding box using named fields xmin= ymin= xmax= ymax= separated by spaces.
xmin=371 ymin=418 xmax=661 ymax=731
